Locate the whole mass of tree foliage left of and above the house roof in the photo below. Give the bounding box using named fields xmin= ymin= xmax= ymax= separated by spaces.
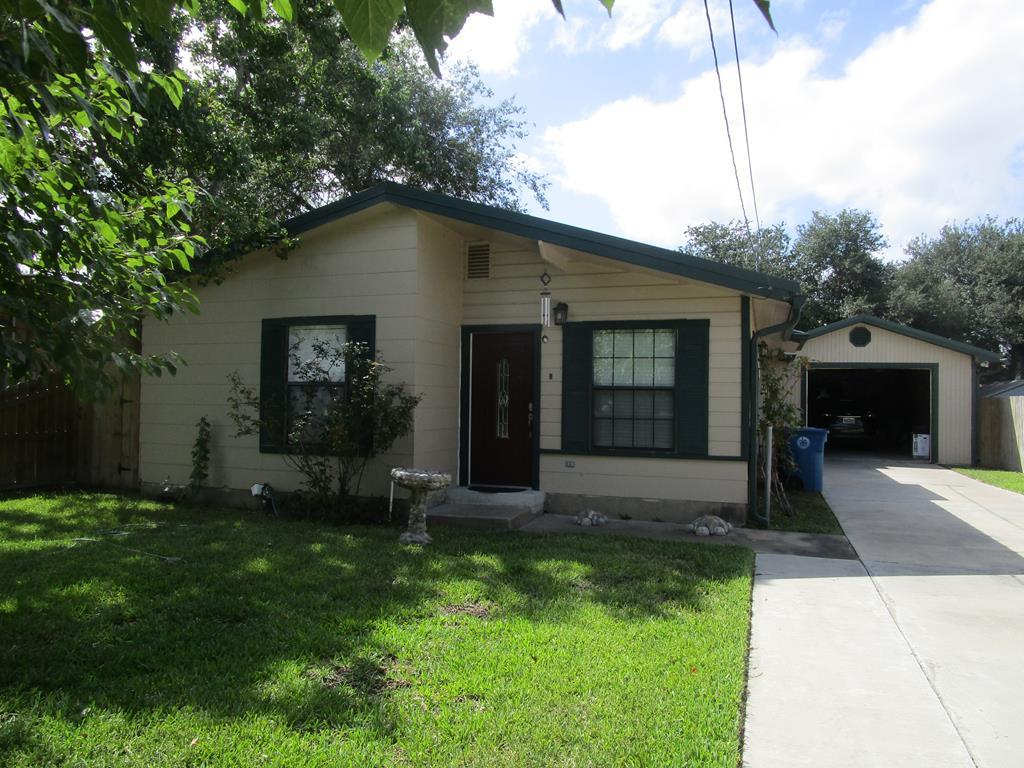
xmin=0 ymin=0 xmax=552 ymax=390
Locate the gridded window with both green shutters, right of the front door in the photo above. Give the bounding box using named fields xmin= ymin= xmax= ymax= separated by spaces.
xmin=562 ymin=321 xmax=710 ymax=457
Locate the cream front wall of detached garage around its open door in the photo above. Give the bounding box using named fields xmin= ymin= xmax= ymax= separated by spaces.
xmin=796 ymin=324 xmax=974 ymax=464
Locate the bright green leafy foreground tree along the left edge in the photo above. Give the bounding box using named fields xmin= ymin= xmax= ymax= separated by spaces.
xmin=0 ymin=1 xmax=203 ymax=391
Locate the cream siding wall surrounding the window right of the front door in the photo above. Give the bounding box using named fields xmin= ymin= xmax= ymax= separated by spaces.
xmin=463 ymin=243 xmax=746 ymax=504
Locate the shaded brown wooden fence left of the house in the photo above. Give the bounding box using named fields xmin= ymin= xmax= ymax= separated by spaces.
xmin=0 ymin=377 xmax=139 ymax=490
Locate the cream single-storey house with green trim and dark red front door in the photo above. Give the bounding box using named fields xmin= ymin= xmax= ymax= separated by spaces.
xmin=139 ymin=183 xmax=803 ymax=520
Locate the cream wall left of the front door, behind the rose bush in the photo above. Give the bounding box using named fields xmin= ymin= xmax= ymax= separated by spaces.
xmin=139 ymin=206 xmax=420 ymax=494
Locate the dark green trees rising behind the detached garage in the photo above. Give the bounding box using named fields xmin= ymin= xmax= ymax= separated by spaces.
xmin=680 ymin=209 xmax=1024 ymax=380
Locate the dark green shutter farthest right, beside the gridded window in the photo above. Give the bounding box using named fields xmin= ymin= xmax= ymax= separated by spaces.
xmin=676 ymin=321 xmax=711 ymax=456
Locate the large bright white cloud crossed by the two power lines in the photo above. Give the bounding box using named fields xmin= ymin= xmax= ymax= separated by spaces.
xmin=544 ymin=0 xmax=1024 ymax=255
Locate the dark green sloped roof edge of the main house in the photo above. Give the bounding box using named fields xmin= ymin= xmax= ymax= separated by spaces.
xmin=284 ymin=181 xmax=800 ymax=302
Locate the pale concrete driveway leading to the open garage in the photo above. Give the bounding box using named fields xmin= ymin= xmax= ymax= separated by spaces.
xmin=743 ymin=458 xmax=1024 ymax=768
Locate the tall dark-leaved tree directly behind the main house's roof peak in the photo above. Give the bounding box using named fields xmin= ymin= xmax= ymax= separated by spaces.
xmin=137 ymin=8 xmax=545 ymax=256
